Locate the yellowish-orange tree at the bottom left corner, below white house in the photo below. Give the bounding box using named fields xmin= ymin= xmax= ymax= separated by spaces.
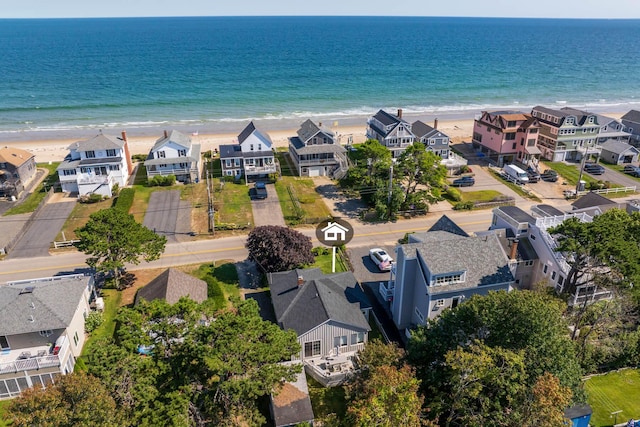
xmin=8 ymin=372 xmax=125 ymax=427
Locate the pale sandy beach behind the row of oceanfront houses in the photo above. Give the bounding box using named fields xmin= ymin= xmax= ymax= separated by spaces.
xmin=0 ymin=113 xmax=624 ymax=163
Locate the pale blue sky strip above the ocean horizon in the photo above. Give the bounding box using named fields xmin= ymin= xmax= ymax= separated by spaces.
xmin=0 ymin=0 xmax=640 ymax=19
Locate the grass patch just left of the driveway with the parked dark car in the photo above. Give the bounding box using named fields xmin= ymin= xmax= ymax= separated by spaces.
xmin=213 ymin=178 xmax=253 ymax=226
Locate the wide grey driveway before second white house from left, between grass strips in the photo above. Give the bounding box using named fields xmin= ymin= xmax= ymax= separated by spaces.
xmin=142 ymin=190 xmax=191 ymax=242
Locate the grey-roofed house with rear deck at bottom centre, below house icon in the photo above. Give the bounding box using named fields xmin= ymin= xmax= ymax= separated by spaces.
xmin=267 ymin=268 xmax=371 ymax=385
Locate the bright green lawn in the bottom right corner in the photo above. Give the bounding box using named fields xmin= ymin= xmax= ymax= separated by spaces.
xmin=584 ymin=369 xmax=640 ymax=427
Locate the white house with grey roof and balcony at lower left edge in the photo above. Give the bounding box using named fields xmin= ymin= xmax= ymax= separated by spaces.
xmin=0 ymin=274 xmax=93 ymax=399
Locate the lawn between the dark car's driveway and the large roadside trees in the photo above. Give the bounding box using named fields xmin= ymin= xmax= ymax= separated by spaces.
xmin=275 ymin=176 xmax=331 ymax=225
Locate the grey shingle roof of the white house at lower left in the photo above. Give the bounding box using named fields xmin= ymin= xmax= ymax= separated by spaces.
xmin=0 ymin=275 xmax=92 ymax=336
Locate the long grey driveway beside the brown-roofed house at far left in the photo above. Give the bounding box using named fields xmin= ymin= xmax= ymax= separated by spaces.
xmin=7 ymin=193 xmax=77 ymax=259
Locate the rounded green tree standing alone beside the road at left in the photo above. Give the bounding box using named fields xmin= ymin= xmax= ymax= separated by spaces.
xmin=75 ymin=208 xmax=167 ymax=289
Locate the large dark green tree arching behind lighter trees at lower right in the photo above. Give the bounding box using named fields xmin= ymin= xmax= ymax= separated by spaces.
xmin=407 ymin=291 xmax=583 ymax=424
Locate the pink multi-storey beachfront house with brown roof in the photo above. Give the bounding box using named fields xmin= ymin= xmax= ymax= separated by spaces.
xmin=471 ymin=111 xmax=540 ymax=167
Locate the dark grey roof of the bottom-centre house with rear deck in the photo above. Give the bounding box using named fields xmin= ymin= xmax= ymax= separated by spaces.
xmin=269 ymin=268 xmax=371 ymax=335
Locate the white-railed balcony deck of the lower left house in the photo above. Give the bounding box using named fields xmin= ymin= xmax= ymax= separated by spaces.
xmin=0 ymin=336 xmax=69 ymax=374
